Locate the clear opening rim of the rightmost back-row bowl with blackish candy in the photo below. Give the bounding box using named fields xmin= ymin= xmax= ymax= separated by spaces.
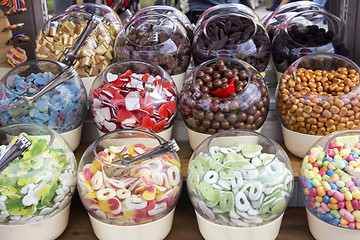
xmin=279 ymin=10 xmax=343 ymax=48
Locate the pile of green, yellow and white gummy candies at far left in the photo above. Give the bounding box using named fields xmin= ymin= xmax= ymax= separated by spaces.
xmin=0 ymin=136 xmax=76 ymax=224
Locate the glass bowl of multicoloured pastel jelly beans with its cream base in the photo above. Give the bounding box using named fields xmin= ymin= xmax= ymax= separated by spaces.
xmin=299 ymin=130 xmax=360 ymax=240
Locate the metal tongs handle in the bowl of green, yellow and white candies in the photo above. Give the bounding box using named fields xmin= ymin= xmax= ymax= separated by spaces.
xmin=0 ymin=135 xmax=31 ymax=172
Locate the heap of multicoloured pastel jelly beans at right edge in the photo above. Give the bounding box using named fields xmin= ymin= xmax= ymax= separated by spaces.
xmin=300 ymin=136 xmax=360 ymax=229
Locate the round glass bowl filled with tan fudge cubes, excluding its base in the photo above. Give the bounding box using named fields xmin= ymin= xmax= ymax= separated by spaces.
xmin=35 ymin=12 xmax=113 ymax=77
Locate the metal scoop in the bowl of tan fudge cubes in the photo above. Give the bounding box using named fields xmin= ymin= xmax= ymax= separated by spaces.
xmin=59 ymin=14 xmax=99 ymax=66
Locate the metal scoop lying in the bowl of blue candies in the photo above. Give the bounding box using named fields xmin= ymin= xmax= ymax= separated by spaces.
xmin=8 ymin=66 xmax=76 ymax=119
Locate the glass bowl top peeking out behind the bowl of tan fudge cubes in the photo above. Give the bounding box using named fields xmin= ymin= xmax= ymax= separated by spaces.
xmin=65 ymin=3 xmax=123 ymax=41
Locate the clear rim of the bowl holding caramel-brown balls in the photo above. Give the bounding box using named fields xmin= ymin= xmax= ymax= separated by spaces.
xmin=289 ymin=52 xmax=360 ymax=99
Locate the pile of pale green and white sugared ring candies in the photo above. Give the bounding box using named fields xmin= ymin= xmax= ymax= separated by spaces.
xmin=186 ymin=142 xmax=293 ymax=226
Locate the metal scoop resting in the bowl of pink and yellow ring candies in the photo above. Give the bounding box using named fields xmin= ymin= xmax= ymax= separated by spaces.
xmin=103 ymin=139 xmax=180 ymax=178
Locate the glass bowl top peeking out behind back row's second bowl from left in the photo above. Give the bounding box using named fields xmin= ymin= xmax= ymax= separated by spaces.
xmin=132 ymin=5 xmax=194 ymax=41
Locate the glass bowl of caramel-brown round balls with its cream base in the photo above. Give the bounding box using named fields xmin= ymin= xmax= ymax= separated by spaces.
xmin=275 ymin=53 xmax=360 ymax=158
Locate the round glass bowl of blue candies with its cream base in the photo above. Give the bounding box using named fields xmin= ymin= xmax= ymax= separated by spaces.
xmin=0 ymin=60 xmax=87 ymax=150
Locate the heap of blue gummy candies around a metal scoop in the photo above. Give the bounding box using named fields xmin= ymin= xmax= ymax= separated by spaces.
xmin=0 ymin=72 xmax=86 ymax=133
